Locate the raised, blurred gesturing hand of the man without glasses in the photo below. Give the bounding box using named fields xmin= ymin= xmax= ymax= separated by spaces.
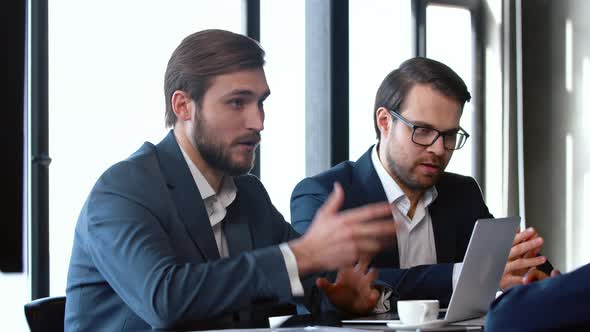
xmin=289 ymin=183 xmax=395 ymax=276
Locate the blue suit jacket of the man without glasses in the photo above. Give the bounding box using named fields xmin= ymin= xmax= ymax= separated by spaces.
xmin=65 ymin=132 xmax=320 ymax=331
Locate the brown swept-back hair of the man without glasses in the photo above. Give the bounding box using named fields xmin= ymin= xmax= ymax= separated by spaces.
xmin=164 ymin=29 xmax=264 ymax=127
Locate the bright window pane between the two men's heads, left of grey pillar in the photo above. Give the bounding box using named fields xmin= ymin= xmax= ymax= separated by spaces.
xmin=260 ymin=0 xmax=305 ymax=220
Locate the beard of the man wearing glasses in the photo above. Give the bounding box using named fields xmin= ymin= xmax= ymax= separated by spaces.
xmin=385 ymin=149 xmax=446 ymax=190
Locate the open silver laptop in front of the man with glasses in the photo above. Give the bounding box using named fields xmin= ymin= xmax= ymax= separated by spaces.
xmin=342 ymin=217 xmax=520 ymax=328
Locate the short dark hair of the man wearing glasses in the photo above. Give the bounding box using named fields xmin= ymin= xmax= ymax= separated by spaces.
xmin=373 ymin=57 xmax=471 ymax=140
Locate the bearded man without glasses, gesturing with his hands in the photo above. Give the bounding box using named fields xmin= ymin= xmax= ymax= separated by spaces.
xmin=65 ymin=30 xmax=395 ymax=331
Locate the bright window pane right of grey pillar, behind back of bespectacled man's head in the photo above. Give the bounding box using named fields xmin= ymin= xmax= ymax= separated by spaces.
xmin=349 ymin=0 xmax=412 ymax=160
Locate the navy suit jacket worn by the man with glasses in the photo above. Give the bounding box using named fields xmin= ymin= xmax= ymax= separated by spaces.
xmin=291 ymin=149 xmax=492 ymax=305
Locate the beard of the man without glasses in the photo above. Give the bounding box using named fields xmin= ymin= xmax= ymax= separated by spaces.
xmin=193 ymin=117 xmax=260 ymax=176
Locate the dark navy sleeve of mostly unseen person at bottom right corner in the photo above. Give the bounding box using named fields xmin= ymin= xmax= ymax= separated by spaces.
xmin=485 ymin=264 xmax=590 ymax=332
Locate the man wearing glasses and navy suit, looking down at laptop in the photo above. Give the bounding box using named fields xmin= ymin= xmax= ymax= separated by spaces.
xmin=291 ymin=57 xmax=547 ymax=305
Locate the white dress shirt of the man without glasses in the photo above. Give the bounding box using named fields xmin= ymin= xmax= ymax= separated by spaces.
xmin=179 ymin=146 xmax=304 ymax=296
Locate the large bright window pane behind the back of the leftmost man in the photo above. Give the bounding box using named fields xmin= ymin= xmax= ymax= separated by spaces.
xmin=49 ymin=0 xmax=244 ymax=295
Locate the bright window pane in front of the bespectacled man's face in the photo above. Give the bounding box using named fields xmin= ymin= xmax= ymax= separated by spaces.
xmin=426 ymin=5 xmax=476 ymax=176
